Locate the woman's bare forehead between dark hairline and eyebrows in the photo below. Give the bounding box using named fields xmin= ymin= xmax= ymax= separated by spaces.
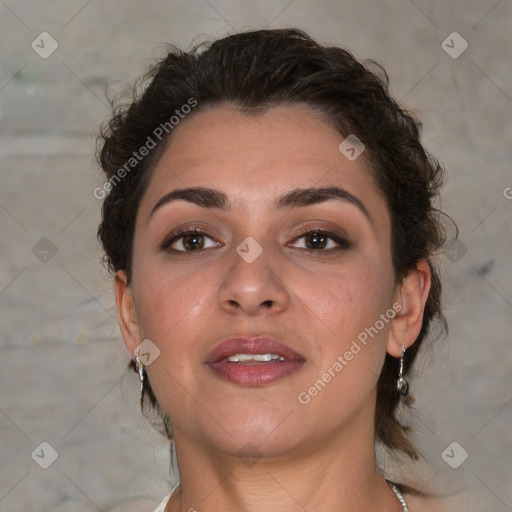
xmin=140 ymin=105 xmax=385 ymax=222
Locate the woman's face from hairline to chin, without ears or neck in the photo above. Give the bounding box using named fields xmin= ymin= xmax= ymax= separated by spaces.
xmin=121 ymin=106 xmax=399 ymax=455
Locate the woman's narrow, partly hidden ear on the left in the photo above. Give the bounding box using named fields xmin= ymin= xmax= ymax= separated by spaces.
xmin=115 ymin=270 xmax=141 ymax=358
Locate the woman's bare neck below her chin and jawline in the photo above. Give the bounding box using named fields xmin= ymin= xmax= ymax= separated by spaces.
xmin=166 ymin=416 xmax=401 ymax=512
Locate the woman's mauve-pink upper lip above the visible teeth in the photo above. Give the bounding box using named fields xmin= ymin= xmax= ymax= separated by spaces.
xmin=206 ymin=336 xmax=304 ymax=363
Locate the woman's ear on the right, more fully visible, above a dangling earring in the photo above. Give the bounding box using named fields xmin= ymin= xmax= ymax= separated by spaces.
xmin=387 ymin=259 xmax=431 ymax=357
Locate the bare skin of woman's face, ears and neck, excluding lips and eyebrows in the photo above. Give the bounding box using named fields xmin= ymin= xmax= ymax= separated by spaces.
xmin=115 ymin=106 xmax=433 ymax=512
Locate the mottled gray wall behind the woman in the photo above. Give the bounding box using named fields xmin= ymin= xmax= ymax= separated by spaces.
xmin=0 ymin=0 xmax=512 ymax=512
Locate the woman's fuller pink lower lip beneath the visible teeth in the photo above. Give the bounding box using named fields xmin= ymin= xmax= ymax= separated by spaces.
xmin=208 ymin=359 xmax=304 ymax=386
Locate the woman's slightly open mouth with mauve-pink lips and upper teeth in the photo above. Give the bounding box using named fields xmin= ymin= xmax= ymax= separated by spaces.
xmin=206 ymin=336 xmax=305 ymax=386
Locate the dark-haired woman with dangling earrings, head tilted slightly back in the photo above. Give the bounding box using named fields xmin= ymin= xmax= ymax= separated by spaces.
xmin=99 ymin=29 xmax=456 ymax=512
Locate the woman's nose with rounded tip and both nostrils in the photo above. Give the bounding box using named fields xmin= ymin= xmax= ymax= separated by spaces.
xmin=218 ymin=240 xmax=290 ymax=316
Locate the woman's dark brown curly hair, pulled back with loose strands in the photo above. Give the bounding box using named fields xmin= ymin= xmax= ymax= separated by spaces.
xmin=97 ymin=29 xmax=447 ymax=459
